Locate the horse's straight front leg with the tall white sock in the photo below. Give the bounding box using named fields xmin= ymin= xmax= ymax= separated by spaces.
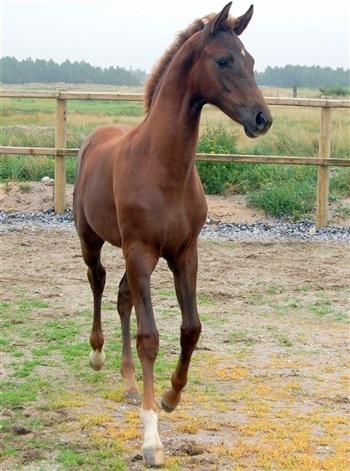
xmin=124 ymin=244 xmax=164 ymax=466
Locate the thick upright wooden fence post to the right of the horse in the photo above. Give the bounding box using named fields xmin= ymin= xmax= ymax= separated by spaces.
xmin=316 ymin=97 xmax=332 ymax=228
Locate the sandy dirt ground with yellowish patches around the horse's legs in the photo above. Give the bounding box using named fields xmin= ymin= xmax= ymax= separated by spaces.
xmin=0 ymin=183 xmax=350 ymax=471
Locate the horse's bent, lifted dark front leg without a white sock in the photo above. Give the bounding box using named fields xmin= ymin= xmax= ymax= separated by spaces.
xmin=162 ymin=244 xmax=201 ymax=412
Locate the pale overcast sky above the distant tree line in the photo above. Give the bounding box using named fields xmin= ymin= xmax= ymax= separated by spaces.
xmin=0 ymin=0 xmax=350 ymax=72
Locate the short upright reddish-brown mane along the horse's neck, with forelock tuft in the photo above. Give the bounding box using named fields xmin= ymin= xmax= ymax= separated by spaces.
xmin=145 ymin=13 xmax=236 ymax=111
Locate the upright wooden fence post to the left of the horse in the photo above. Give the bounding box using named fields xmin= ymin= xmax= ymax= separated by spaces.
xmin=55 ymin=98 xmax=67 ymax=213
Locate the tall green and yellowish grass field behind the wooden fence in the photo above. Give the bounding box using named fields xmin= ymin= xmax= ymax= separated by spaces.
xmin=0 ymin=86 xmax=350 ymax=219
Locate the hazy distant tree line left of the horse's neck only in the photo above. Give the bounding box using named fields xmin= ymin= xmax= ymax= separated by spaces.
xmin=0 ymin=56 xmax=146 ymax=87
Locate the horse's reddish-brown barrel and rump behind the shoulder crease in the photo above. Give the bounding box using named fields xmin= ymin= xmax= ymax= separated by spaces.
xmin=73 ymin=126 xmax=127 ymax=245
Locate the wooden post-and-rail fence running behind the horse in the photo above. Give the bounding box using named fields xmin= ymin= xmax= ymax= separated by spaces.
xmin=0 ymin=91 xmax=350 ymax=228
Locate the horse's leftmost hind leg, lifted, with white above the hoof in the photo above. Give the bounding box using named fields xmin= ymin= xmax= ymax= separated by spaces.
xmin=81 ymin=236 xmax=106 ymax=371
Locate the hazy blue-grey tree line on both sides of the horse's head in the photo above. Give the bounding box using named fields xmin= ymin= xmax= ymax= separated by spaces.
xmin=0 ymin=57 xmax=350 ymax=92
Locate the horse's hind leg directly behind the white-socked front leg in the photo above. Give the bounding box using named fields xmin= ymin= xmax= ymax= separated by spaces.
xmin=118 ymin=273 xmax=140 ymax=400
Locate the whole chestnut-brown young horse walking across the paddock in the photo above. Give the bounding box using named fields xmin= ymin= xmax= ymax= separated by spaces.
xmin=74 ymin=3 xmax=272 ymax=465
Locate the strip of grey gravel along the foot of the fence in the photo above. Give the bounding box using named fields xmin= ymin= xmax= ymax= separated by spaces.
xmin=0 ymin=209 xmax=350 ymax=242
